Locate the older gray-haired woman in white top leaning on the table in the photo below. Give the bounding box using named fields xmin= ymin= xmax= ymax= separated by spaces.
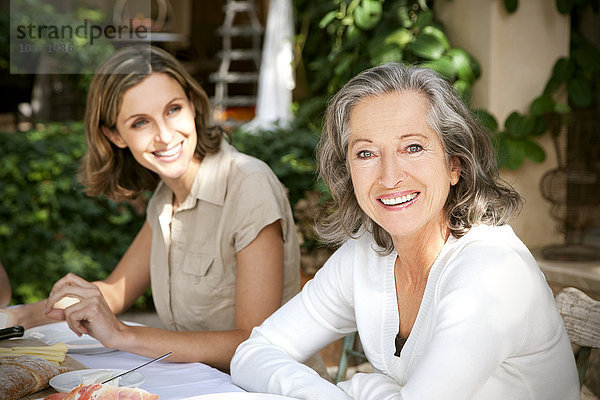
xmin=231 ymin=64 xmax=578 ymax=400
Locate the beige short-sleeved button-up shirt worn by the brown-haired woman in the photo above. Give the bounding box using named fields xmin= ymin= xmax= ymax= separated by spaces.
xmin=147 ymin=141 xmax=300 ymax=331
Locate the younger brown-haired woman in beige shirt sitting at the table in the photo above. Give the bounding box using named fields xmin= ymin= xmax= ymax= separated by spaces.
xmin=7 ymin=46 xmax=299 ymax=369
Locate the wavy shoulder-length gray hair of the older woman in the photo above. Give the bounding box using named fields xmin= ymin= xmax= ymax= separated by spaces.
xmin=316 ymin=63 xmax=522 ymax=254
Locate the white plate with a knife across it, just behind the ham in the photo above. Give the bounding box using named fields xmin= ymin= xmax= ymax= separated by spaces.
xmin=50 ymin=368 xmax=146 ymax=393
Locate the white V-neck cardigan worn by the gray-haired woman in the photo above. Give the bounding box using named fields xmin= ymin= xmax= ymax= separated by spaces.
xmin=231 ymin=225 xmax=579 ymax=400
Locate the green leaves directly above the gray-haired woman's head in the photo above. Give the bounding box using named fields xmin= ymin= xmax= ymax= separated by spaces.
xmin=295 ymin=0 xmax=480 ymax=106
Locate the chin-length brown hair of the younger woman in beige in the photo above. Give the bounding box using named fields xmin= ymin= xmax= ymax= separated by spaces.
xmin=80 ymin=45 xmax=223 ymax=201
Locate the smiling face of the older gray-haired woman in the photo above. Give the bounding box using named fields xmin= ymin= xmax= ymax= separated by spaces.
xmin=348 ymin=91 xmax=460 ymax=244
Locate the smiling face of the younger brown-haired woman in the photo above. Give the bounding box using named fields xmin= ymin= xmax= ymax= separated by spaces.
xmin=105 ymin=73 xmax=198 ymax=180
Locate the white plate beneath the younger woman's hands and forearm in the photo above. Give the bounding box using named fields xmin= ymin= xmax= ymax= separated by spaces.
xmin=23 ymin=321 xmax=142 ymax=354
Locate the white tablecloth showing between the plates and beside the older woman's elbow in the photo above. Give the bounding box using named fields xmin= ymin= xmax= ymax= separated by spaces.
xmin=69 ymin=351 xmax=243 ymax=400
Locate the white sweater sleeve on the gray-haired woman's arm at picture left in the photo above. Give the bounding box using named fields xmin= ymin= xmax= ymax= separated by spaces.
xmin=231 ymin=242 xmax=356 ymax=400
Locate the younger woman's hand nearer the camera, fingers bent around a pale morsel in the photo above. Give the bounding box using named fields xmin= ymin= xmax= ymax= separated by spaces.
xmin=45 ymin=273 xmax=125 ymax=348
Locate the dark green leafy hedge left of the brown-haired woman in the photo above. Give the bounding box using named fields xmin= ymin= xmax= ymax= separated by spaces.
xmin=0 ymin=123 xmax=145 ymax=303
